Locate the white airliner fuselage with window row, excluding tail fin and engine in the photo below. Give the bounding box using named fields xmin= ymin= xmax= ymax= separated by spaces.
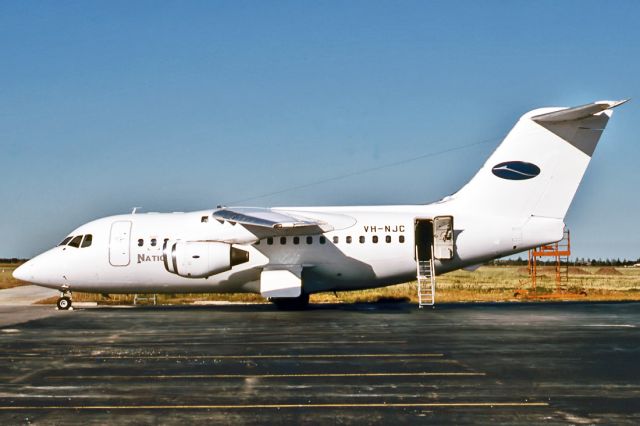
xmin=11 ymin=202 xmax=563 ymax=293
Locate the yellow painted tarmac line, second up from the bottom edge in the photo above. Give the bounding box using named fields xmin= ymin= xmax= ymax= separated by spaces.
xmin=46 ymin=371 xmax=487 ymax=380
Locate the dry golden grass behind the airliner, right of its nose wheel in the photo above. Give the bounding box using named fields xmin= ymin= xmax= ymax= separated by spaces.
xmin=31 ymin=266 xmax=640 ymax=304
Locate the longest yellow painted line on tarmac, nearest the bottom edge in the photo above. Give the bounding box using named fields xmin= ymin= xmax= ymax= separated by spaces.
xmin=0 ymin=402 xmax=549 ymax=411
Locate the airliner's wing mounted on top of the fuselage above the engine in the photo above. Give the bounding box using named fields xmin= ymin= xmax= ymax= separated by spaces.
xmin=213 ymin=207 xmax=334 ymax=235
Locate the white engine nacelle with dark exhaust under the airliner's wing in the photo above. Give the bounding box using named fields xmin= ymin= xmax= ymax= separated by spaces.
xmin=162 ymin=241 xmax=249 ymax=278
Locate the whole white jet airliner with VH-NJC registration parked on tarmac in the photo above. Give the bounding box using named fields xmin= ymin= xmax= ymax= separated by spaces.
xmin=13 ymin=101 xmax=625 ymax=309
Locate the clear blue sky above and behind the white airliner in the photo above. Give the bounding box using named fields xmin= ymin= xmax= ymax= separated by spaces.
xmin=0 ymin=1 xmax=640 ymax=258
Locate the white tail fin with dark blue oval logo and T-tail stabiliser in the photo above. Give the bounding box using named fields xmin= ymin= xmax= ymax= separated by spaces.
xmin=452 ymin=100 xmax=626 ymax=219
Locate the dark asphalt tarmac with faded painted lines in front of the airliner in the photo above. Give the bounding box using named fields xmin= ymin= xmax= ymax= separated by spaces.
xmin=0 ymin=303 xmax=640 ymax=424
